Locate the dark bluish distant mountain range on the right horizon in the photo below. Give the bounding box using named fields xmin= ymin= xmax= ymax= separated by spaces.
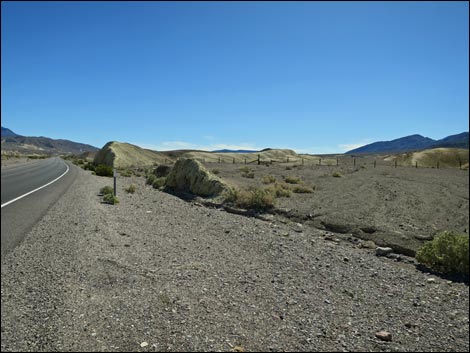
xmin=346 ymin=132 xmax=469 ymax=154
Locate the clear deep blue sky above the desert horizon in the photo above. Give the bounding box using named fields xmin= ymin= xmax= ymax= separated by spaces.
xmin=1 ymin=1 xmax=469 ymax=153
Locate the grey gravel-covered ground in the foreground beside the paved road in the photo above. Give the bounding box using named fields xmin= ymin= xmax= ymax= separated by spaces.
xmin=1 ymin=164 xmax=469 ymax=351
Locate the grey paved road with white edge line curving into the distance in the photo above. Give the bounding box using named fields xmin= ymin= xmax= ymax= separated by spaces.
xmin=1 ymin=158 xmax=77 ymax=260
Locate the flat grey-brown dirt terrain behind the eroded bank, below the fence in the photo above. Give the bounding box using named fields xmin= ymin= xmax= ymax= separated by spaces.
xmin=205 ymin=157 xmax=469 ymax=256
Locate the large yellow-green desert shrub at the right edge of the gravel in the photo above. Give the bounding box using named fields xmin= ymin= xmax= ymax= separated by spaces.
xmin=416 ymin=231 xmax=469 ymax=277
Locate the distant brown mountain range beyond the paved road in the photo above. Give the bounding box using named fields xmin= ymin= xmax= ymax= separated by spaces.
xmin=1 ymin=126 xmax=99 ymax=154
